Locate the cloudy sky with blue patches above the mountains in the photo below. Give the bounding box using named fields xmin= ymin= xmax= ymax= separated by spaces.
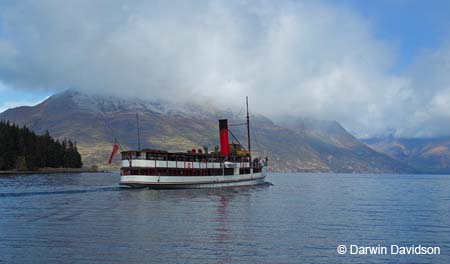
xmin=0 ymin=0 xmax=450 ymax=137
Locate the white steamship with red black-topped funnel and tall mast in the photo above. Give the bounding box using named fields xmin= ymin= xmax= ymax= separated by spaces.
xmin=120 ymin=97 xmax=268 ymax=189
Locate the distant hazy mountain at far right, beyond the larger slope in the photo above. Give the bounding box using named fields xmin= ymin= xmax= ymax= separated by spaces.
xmin=363 ymin=137 xmax=450 ymax=173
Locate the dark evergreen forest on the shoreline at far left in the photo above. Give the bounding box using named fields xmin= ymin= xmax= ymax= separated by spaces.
xmin=0 ymin=121 xmax=83 ymax=170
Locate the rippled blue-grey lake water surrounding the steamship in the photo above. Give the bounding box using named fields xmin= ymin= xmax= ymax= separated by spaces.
xmin=0 ymin=172 xmax=450 ymax=263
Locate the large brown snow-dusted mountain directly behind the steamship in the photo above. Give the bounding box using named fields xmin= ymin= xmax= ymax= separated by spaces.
xmin=0 ymin=90 xmax=413 ymax=173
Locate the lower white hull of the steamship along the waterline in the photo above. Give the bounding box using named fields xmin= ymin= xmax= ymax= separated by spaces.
xmin=120 ymin=168 xmax=266 ymax=189
